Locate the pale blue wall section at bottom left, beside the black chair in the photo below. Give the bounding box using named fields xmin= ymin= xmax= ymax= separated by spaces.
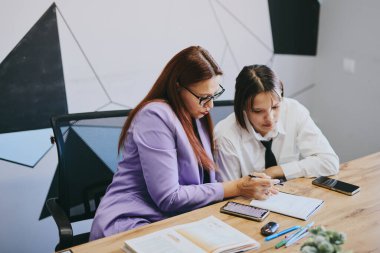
xmin=0 ymin=149 xmax=58 ymax=253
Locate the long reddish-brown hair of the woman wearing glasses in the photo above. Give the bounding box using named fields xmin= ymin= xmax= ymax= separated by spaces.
xmin=119 ymin=46 xmax=223 ymax=169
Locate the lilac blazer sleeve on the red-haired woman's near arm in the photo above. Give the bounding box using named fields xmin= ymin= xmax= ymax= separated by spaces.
xmin=133 ymin=103 xmax=224 ymax=212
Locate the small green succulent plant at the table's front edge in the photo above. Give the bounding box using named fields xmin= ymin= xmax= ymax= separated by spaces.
xmin=301 ymin=226 xmax=352 ymax=253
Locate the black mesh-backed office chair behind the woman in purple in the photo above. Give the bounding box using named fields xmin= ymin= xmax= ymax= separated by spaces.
xmin=46 ymin=110 xmax=130 ymax=251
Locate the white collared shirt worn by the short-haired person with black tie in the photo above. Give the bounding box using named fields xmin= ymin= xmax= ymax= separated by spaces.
xmin=214 ymin=98 xmax=339 ymax=181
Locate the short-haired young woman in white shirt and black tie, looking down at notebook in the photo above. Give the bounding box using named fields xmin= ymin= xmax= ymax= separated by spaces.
xmin=215 ymin=65 xmax=339 ymax=181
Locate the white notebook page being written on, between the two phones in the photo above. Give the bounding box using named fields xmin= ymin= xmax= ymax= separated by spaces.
xmin=251 ymin=192 xmax=323 ymax=220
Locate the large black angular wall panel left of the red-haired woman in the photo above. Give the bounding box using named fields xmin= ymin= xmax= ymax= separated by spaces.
xmin=0 ymin=4 xmax=67 ymax=133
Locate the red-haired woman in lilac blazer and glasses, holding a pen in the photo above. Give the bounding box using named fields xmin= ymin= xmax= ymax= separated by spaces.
xmin=90 ymin=46 xmax=276 ymax=240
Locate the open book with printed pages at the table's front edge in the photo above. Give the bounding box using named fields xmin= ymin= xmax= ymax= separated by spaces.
xmin=123 ymin=216 xmax=260 ymax=253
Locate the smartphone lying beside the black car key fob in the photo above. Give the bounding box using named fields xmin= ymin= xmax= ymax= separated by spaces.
xmin=220 ymin=201 xmax=269 ymax=221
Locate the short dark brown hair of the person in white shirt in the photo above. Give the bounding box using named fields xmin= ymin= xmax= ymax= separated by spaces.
xmin=234 ymin=65 xmax=284 ymax=130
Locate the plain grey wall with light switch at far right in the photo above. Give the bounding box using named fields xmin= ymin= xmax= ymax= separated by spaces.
xmin=310 ymin=0 xmax=380 ymax=162
